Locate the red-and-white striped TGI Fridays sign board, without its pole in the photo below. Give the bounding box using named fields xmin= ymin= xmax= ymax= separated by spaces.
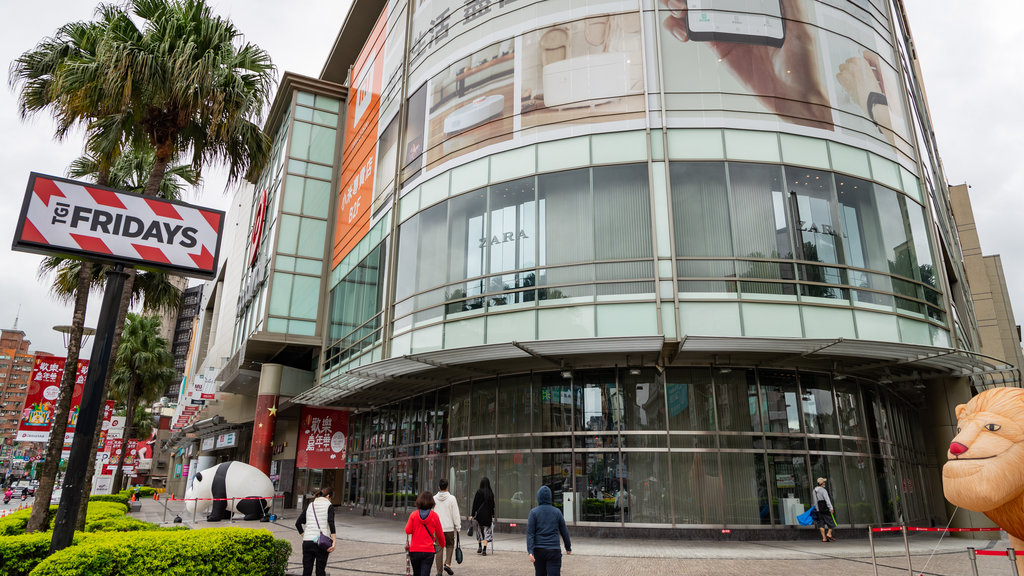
xmin=13 ymin=172 xmax=224 ymax=278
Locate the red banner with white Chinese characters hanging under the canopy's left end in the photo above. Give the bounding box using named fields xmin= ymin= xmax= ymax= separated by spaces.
xmin=295 ymin=406 xmax=348 ymax=469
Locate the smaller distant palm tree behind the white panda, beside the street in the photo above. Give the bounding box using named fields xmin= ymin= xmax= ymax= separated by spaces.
xmin=111 ymin=313 xmax=175 ymax=489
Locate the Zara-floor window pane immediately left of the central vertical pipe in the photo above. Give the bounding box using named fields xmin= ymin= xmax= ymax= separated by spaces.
xmin=593 ymin=164 xmax=653 ymax=259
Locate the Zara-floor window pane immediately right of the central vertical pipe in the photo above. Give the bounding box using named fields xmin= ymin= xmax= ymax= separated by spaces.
xmin=669 ymin=162 xmax=732 ymax=256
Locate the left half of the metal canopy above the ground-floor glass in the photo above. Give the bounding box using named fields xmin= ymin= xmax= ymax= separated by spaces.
xmin=290 ymin=336 xmax=665 ymax=407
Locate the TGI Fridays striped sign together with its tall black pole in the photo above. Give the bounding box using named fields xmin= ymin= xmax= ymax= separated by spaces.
xmin=13 ymin=172 xmax=224 ymax=552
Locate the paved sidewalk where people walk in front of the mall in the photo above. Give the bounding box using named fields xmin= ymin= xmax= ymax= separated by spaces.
xmin=132 ymin=500 xmax=1011 ymax=576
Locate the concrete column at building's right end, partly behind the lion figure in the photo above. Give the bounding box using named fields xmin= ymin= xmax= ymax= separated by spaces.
xmin=923 ymin=378 xmax=995 ymax=539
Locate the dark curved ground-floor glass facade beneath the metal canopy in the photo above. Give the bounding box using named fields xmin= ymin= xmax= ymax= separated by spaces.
xmin=344 ymin=367 xmax=928 ymax=528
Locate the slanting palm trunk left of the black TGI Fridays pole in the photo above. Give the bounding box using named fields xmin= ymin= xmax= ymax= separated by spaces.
xmin=25 ymin=261 xmax=92 ymax=532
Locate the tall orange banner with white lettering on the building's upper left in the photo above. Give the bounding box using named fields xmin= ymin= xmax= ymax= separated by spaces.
xmin=334 ymin=13 xmax=387 ymax=265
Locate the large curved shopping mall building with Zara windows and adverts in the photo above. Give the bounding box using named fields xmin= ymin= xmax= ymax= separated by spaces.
xmin=168 ymin=0 xmax=1021 ymax=530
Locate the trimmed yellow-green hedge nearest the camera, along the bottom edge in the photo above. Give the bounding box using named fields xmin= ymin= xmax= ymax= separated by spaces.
xmin=32 ymin=528 xmax=292 ymax=576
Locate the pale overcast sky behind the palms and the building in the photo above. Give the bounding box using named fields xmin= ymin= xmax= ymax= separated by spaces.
xmin=0 ymin=0 xmax=1024 ymax=353
